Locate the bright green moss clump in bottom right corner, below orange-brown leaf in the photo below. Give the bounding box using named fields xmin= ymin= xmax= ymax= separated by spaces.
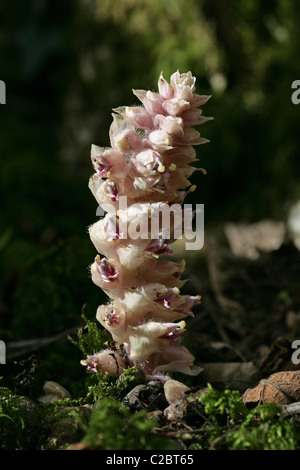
xmin=189 ymin=385 xmax=300 ymax=450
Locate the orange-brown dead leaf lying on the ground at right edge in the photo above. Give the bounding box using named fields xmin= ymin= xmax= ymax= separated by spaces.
xmin=242 ymin=371 xmax=300 ymax=405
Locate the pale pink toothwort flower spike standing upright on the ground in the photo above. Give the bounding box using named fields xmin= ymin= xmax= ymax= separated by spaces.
xmin=83 ymin=71 xmax=212 ymax=398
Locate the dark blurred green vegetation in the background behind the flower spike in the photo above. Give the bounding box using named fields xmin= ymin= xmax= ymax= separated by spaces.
xmin=0 ymin=0 xmax=300 ymax=392
